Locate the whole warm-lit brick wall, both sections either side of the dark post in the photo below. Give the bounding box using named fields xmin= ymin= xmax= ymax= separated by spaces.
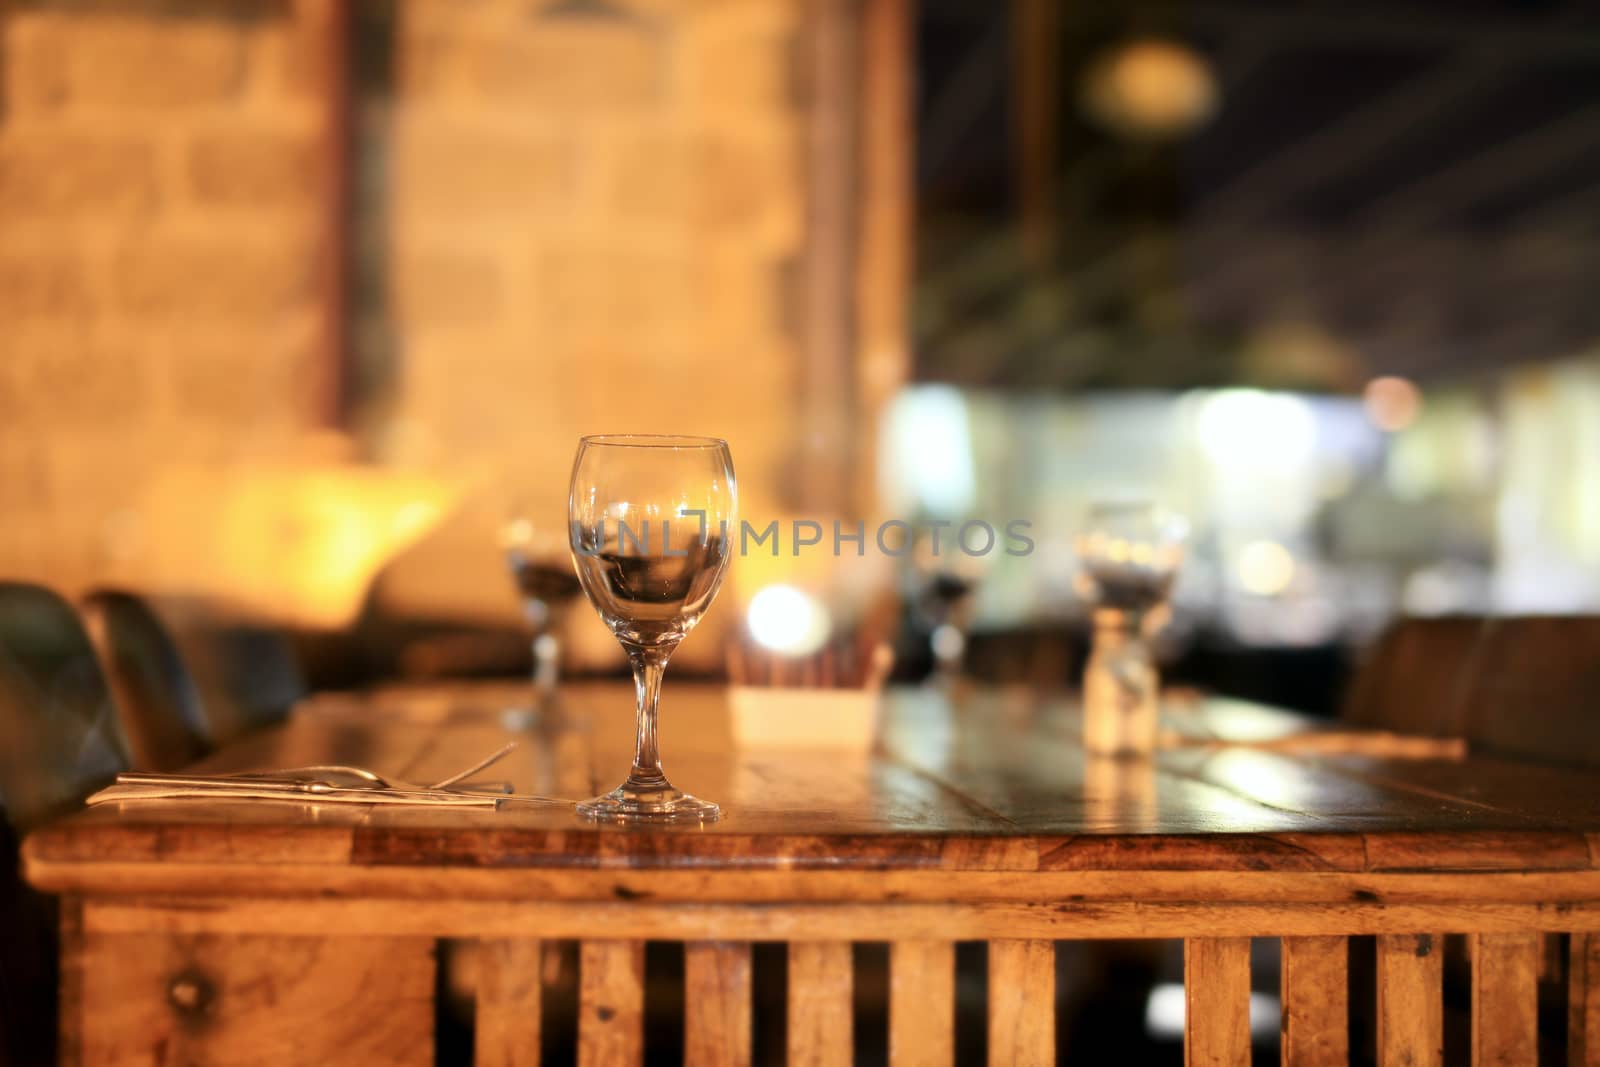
xmin=0 ymin=0 xmax=889 ymax=633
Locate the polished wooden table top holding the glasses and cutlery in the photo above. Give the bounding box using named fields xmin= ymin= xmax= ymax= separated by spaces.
xmin=24 ymin=677 xmax=1600 ymax=899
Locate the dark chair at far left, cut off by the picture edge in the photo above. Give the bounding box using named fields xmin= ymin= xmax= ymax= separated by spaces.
xmin=0 ymin=582 xmax=128 ymax=1064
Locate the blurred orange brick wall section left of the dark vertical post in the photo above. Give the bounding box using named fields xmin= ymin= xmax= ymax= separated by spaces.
xmin=0 ymin=0 xmax=320 ymax=587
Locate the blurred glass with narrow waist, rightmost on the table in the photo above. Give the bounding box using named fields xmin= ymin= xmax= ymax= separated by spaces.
xmin=1077 ymin=501 xmax=1189 ymax=755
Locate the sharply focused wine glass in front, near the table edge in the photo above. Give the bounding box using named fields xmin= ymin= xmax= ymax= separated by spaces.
xmin=568 ymin=434 xmax=738 ymax=821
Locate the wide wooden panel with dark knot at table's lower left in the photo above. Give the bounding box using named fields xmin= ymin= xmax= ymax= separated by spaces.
xmin=72 ymin=933 xmax=434 ymax=1067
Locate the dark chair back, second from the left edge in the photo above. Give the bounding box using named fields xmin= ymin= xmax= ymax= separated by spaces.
xmin=82 ymin=590 xmax=211 ymax=771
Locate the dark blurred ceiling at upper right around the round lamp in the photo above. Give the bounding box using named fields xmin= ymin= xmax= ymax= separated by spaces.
xmin=917 ymin=0 xmax=1600 ymax=389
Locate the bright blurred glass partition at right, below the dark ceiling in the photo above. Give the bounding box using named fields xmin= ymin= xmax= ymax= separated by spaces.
xmin=880 ymin=362 xmax=1600 ymax=646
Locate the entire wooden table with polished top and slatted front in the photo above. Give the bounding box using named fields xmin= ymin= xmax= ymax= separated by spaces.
xmin=26 ymin=681 xmax=1600 ymax=1065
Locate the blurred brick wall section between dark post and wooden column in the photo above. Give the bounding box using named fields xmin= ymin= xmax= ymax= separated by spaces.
xmin=368 ymin=0 xmax=806 ymax=627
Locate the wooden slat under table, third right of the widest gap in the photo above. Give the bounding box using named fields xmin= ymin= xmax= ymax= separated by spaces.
xmin=1378 ymin=934 xmax=1445 ymax=1067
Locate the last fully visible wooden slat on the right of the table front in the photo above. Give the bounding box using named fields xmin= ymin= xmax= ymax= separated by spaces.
xmin=1470 ymin=934 xmax=1539 ymax=1067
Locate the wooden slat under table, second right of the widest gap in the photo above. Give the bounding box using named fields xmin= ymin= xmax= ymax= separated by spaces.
xmin=1283 ymin=937 xmax=1350 ymax=1067
